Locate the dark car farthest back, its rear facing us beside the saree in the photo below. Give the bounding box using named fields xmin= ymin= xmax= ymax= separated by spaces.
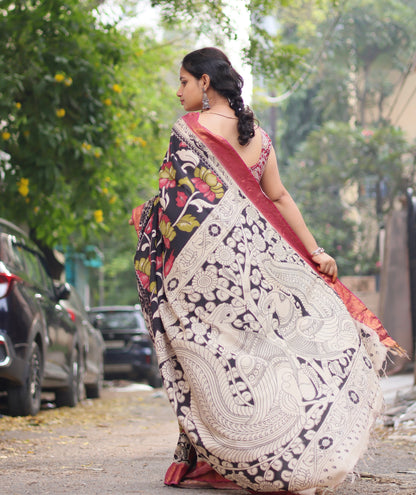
xmin=88 ymin=305 xmax=162 ymax=387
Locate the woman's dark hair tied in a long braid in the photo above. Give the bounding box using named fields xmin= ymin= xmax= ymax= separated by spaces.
xmin=182 ymin=47 xmax=254 ymax=145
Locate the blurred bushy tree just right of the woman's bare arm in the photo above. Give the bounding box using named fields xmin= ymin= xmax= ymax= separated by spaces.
xmin=282 ymin=122 xmax=415 ymax=275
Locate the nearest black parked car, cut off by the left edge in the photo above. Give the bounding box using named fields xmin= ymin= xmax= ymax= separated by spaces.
xmin=0 ymin=219 xmax=82 ymax=416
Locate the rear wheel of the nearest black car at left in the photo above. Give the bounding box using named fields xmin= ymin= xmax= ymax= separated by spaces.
xmin=7 ymin=342 xmax=42 ymax=416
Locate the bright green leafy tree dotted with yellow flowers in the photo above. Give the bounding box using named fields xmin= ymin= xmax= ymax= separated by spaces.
xmin=0 ymin=0 xmax=179 ymax=256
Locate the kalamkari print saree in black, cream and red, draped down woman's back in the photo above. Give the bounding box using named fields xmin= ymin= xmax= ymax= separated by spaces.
xmin=133 ymin=114 xmax=396 ymax=493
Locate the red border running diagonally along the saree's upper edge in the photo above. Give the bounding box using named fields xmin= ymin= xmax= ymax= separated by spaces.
xmin=182 ymin=113 xmax=400 ymax=351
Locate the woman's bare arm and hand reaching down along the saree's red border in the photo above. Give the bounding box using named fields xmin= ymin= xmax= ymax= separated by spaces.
xmin=260 ymin=148 xmax=338 ymax=282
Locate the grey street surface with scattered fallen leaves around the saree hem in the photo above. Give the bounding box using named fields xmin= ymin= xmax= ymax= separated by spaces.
xmin=0 ymin=375 xmax=416 ymax=495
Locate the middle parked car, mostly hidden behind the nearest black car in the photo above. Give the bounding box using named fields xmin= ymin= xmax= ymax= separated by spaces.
xmin=60 ymin=286 xmax=105 ymax=399
